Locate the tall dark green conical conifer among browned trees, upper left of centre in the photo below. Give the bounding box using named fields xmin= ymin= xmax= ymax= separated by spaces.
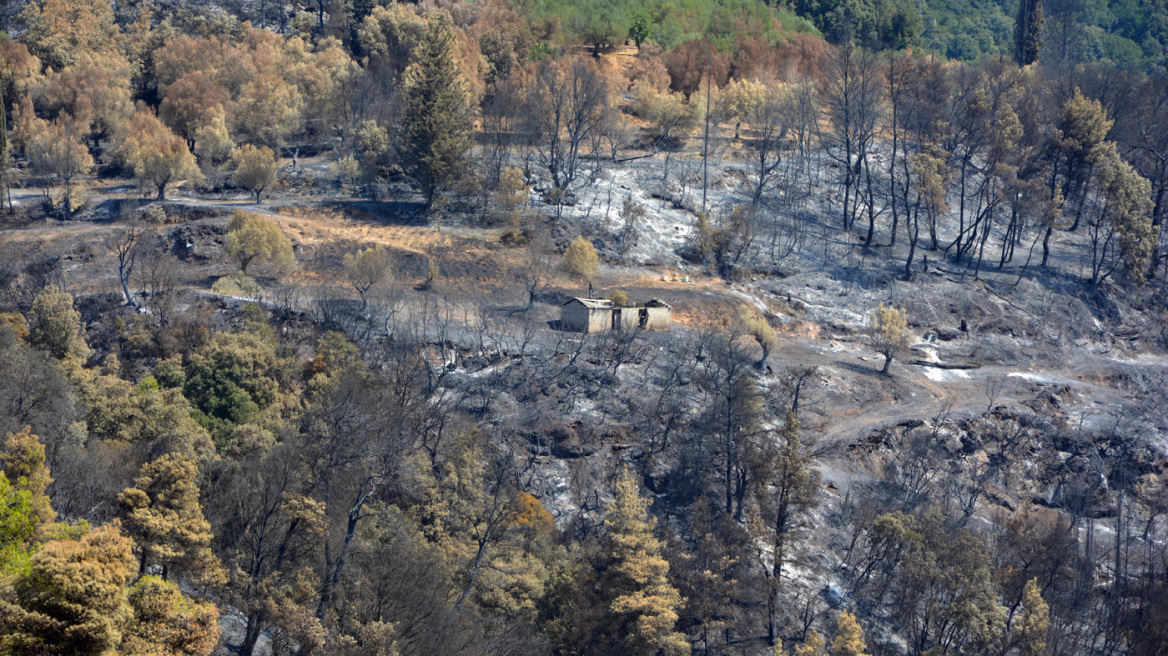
xmin=398 ymin=14 xmax=472 ymax=210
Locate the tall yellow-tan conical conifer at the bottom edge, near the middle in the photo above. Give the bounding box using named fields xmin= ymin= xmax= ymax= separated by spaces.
xmin=604 ymin=468 xmax=689 ymax=656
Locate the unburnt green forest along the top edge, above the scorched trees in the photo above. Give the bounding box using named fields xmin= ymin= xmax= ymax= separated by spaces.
xmin=521 ymin=0 xmax=1168 ymax=71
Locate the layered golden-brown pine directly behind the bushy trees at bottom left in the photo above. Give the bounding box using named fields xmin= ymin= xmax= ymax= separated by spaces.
xmin=118 ymin=453 xmax=222 ymax=581
